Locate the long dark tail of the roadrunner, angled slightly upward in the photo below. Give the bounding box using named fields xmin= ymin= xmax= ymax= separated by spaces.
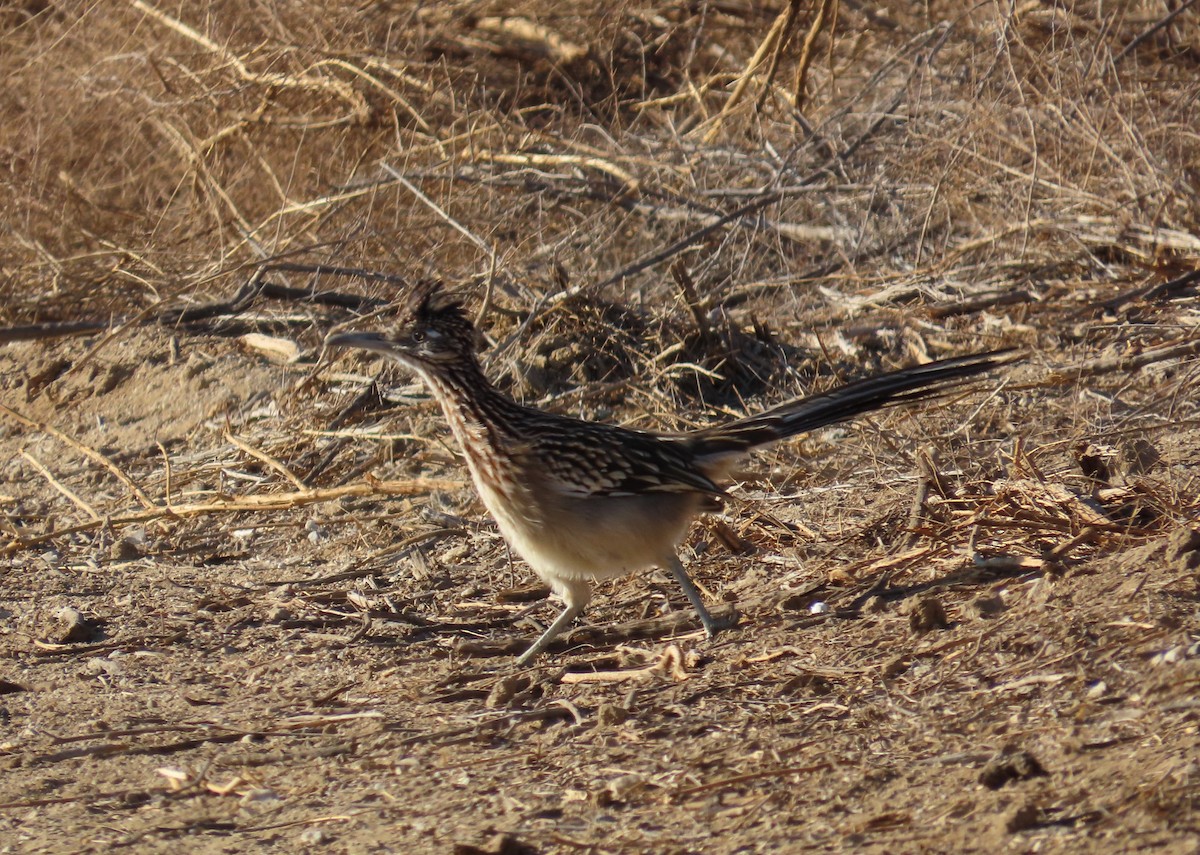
xmin=688 ymin=348 xmax=1024 ymax=458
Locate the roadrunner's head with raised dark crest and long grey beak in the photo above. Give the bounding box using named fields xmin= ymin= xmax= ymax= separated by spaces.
xmin=325 ymin=282 xmax=478 ymax=372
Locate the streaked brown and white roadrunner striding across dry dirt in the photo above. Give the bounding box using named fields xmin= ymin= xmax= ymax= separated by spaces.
xmin=325 ymin=285 xmax=1013 ymax=665
